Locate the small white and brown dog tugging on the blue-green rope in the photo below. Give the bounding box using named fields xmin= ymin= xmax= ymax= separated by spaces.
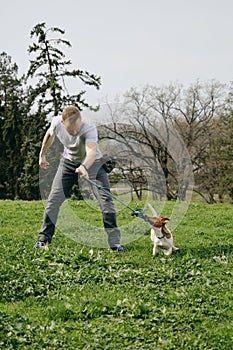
xmin=145 ymin=204 xmax=180 ymax=255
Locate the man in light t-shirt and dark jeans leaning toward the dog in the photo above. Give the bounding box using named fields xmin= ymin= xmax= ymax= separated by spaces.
xmin=34 ymin=106 xmax=125 ymax=251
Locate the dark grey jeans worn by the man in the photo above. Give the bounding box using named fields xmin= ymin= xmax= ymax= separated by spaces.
xmin=39 ymin=159 xmax=121 ymax=247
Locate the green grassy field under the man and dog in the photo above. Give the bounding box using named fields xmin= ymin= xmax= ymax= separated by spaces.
xmin=0 ymin=201 xmax=233 ymax=350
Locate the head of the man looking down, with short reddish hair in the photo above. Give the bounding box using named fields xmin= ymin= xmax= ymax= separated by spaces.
xmin=62 ymin=106 xmax=81 ymax=135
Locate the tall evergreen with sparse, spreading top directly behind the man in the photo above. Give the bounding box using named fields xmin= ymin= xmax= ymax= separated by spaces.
xmin=17 ymin=23 xmax=100 ymax=199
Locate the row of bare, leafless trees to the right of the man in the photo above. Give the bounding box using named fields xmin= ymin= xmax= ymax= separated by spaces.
xmin=100 ymin=81 xmax=233 ymax=203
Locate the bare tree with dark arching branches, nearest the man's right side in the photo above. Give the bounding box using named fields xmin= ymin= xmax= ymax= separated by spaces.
xmin=98 ymin=85 xmax=189 ymax=199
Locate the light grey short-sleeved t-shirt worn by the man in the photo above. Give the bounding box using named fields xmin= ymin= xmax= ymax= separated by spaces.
xmin=50 ymin=115 xmax=102 ymax=163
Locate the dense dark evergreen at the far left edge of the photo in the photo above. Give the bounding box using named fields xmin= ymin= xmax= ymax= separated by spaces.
xmin=0 ymin=52 xmax=25 ymax=199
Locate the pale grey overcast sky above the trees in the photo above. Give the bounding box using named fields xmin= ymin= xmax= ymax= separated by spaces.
xmin=0 ymin=0 xmax=233 ymax=103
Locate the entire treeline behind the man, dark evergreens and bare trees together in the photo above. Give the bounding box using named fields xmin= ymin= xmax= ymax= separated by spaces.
xmin=0 ymin=23 xmax=233 ymax=203
